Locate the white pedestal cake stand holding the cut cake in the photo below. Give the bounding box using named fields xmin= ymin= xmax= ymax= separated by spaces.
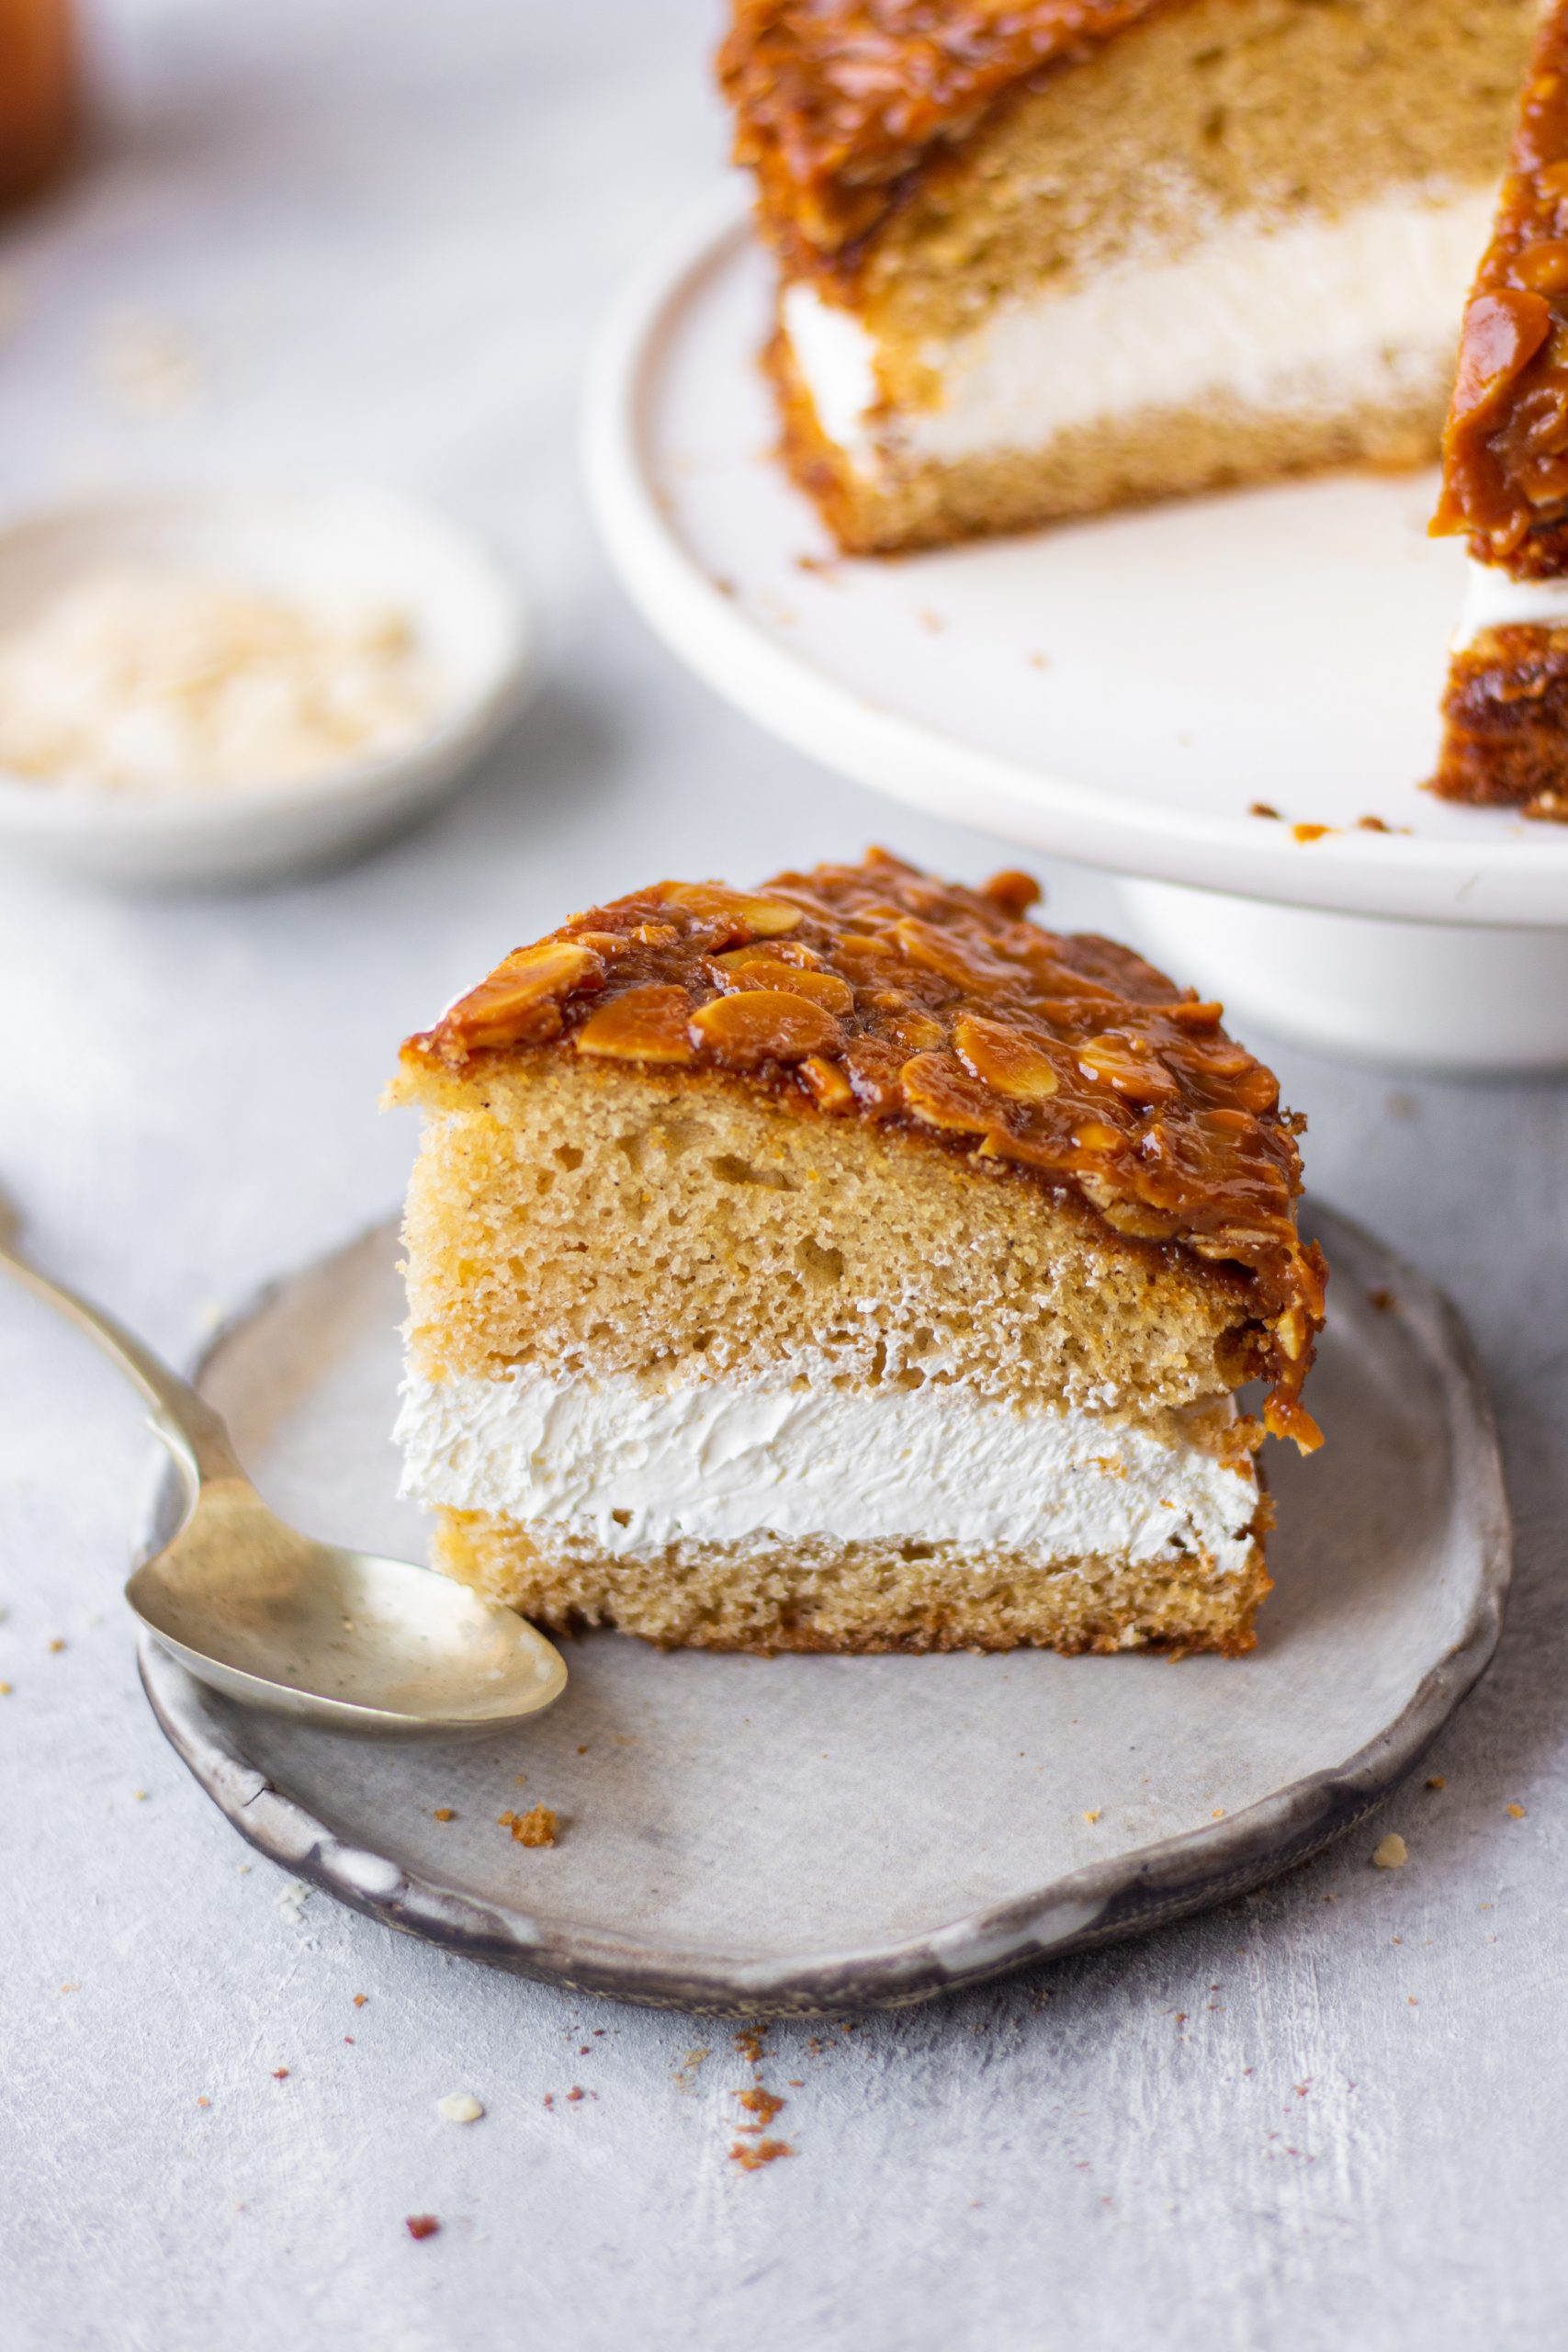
xmin=585 ymin=188 xmax=1568 ymax=1070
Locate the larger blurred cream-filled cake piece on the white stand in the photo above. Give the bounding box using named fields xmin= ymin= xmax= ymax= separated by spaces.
xmin=719 ymin=0 xmax=1538 ymax=550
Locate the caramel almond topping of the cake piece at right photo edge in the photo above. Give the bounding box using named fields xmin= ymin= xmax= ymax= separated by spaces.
xmin=1432 ymin=0 xmax=1568 ymax=579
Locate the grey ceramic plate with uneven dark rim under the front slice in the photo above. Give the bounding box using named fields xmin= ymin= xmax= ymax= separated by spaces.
xmin=141 ymin=1209 xmax=1509 ymax=2016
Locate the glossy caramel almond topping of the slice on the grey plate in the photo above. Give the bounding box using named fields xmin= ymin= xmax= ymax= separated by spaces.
xmin=404 ymin=852 xmax=1324 ymax=1444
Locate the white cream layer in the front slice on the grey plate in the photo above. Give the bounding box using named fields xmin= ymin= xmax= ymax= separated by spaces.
xmin=395 ymin=1371 xmax=1258 ymax=1574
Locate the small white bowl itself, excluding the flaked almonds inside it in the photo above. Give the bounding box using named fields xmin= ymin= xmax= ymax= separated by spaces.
xmin=0 ymin=489 xmax=534 ymax=887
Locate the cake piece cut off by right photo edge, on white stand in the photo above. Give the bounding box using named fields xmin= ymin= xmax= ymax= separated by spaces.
xmin=1432 ymin=5 xmax=1568 ymax=823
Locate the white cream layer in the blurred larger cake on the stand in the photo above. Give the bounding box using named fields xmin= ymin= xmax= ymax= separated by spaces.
xmin=783 ymin=188 xmax=1493 ymax=473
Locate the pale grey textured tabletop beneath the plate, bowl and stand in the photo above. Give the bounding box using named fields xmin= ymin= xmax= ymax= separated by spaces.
xmin=0 ymin=0 xmax=1568 ymax=2352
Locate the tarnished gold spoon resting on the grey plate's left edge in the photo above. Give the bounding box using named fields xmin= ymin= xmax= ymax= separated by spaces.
xmin=0 ymin=1197 xmax=567 ymax=1734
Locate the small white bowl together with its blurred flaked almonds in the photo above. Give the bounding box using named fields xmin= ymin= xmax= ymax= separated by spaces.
xmin=0 ymin=489 xmax=534 ymax=887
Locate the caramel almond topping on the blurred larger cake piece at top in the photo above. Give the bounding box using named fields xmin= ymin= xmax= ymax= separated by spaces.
xmin=719 ymin=0 xmax=1176 ymax=270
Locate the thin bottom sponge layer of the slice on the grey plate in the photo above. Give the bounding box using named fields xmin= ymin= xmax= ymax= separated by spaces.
xmin=434 ymin=1505 xmax=1269 ymax=1656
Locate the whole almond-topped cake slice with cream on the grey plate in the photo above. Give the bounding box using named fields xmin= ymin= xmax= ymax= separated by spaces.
xmin=395 ymin=854 xmax=1325 ymax=1651
